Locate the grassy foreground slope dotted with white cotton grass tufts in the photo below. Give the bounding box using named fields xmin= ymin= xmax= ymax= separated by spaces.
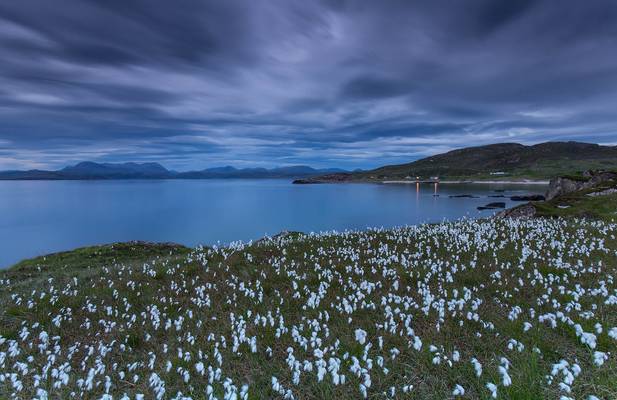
xmin=0 ymin=219 xmax=617 ymax=399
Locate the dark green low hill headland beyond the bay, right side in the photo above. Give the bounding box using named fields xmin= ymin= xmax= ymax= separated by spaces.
xmin=295 ymin=142 xmax=617 ymax=183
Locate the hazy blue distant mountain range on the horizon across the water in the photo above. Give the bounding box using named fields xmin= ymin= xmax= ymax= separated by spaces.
xmin=0 ymin=161 xmax=346 ymax=180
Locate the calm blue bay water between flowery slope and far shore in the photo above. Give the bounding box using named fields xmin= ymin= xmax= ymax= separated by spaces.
xmin=0 ymin=180 xmax=545 ymax=268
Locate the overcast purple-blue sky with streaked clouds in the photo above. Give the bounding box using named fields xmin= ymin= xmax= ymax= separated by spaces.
xmin=0 ymin=0 xmax=617 ymax=170
